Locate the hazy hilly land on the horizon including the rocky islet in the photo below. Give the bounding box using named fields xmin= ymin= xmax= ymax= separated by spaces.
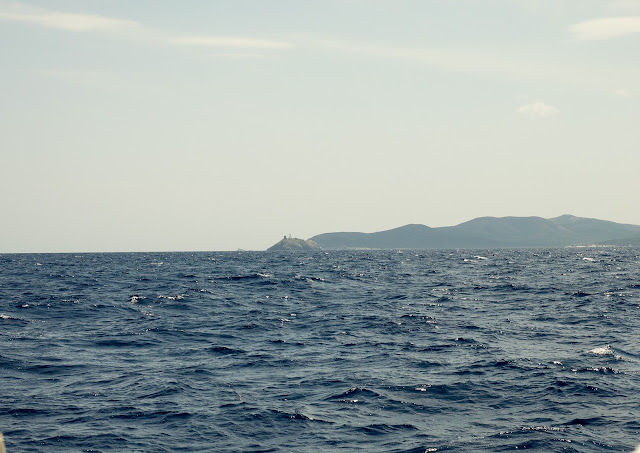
xmin=268 ymin=214 xmax=640 ymax=250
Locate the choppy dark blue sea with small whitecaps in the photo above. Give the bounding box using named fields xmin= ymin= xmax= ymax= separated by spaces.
xmin=0 ymin=247 xmax=640 ymax=453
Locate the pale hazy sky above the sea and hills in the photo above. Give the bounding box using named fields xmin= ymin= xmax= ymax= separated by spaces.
xmin=0 ymin=0 xmax=640 ymax=253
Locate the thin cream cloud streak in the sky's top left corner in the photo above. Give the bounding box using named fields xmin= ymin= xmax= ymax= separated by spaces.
xmin=0 ymin=3 xmax=139 ymax=32
